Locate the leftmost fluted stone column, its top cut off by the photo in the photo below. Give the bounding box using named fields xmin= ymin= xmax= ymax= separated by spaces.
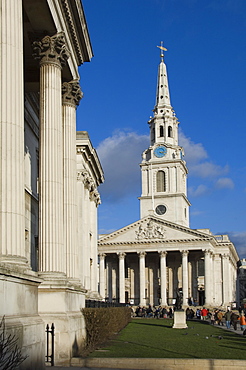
xmin=0 ymin=0 xmax=27 ymax=265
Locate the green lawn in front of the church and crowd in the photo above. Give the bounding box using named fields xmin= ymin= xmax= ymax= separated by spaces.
xmin=89 ymin=319 xmax=246 ymax=360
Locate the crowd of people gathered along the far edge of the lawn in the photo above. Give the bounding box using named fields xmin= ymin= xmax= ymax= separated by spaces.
xmin=132 ymin=305 xmax=246 ymax=335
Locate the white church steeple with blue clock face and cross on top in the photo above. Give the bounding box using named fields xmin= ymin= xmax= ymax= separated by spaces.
xmin=139 ymin=43 xmax=190 ymax=227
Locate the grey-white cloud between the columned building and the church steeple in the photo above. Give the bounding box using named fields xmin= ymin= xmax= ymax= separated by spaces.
xmin=97 ymin=131 xmax=149 ymax=202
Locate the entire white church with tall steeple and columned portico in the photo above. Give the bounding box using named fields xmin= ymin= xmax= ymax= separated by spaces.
xmin=98 ymin=46 xmax=239 ymax=307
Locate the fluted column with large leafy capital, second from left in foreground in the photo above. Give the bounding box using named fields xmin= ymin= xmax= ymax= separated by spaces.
xmin=33 ymin=32 xmax=69 ymax=273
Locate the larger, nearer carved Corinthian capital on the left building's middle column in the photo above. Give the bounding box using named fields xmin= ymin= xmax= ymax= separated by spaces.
xmin=33 ymin=32 xmax=70 ymax=66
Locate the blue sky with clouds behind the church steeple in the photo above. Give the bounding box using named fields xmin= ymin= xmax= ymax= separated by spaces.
xmin=77 ymin=0 xmax=246 ymax=258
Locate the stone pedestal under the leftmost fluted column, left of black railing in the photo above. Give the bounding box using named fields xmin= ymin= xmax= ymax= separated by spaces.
xmin=0 ymin=264 xmax=45 ymax=370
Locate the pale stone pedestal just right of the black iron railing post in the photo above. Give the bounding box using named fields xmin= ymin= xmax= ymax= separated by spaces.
xmin=39 ymin=274 xmax=86 ymax=366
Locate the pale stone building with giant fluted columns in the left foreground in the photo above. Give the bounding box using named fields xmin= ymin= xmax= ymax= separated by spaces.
xmin=0 ymin=0 xmax=104 ymax=370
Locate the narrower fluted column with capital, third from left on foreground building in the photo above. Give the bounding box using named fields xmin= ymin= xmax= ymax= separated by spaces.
xmin=62 ymin=80 xmax=82 ymax=279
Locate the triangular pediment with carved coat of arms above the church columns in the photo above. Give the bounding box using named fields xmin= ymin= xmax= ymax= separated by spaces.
xmin=99 ymin=216 xmax=213 ymax=245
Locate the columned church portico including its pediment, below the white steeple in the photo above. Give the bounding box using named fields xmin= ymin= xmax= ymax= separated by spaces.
xmin=99 ymin=217 xmax=235 ymax=307
